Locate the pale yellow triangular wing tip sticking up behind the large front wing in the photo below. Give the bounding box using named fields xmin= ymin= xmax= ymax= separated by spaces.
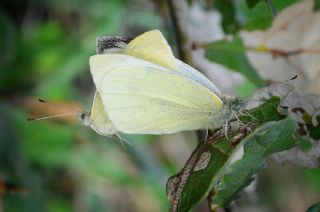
xmin=122 ymin=30 xmax=178 ymax=70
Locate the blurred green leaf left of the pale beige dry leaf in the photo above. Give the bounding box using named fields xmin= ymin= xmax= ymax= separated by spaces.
xmin=205 ymin=36 xmax=264 ymax=87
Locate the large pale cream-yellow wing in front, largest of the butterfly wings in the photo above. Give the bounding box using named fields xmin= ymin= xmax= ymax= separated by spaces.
xmin=90 ymin=54 xmax=222 ymax=134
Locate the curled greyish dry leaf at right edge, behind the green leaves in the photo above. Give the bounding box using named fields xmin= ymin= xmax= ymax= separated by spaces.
xmin=248 ymin=83 xmax=320 ymax=168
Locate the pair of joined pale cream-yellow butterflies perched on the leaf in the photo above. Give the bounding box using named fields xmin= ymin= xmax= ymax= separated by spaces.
xmin=80 ymin=30 xmax=237 ymax=136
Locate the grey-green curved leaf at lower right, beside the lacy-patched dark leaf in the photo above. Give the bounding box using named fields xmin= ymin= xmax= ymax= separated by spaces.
xmin=212 ymin=118 xmax=296 ymax=206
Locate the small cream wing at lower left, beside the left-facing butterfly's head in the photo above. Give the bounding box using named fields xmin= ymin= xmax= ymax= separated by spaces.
xmin=89 ymin=91 xmax=116 ymax=136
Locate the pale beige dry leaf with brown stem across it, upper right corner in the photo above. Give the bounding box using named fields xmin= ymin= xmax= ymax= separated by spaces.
xmin=241 ymin=0 xmax=320 ymax=92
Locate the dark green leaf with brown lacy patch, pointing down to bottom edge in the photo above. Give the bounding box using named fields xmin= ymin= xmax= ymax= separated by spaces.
xmin=167 ymin=144 xmax=229 ymax=211
